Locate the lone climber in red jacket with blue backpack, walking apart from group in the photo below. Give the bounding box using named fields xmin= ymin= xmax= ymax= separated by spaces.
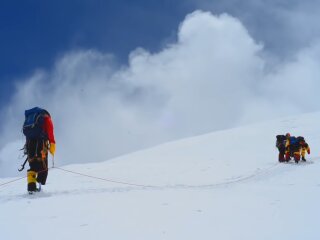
xmin=23 ymin=107 xmax=55 ymax=194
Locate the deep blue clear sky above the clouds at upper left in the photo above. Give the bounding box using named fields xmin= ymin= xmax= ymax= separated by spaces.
xmin=0 ymin=0 xmax=194 ymax=104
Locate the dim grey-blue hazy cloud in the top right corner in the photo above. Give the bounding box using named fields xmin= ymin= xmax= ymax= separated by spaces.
xmin=189 ymin=0 xmax=320 ymax=59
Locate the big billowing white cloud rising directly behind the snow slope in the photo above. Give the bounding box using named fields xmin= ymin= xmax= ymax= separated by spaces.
xmin=0 ymin=11 xmax=319 ymax=175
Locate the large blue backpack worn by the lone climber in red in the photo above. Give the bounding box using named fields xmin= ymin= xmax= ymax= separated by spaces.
xmin=22 ymin=107 xmax=49 ymax=139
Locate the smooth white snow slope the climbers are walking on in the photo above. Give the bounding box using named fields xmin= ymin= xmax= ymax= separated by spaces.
xmin=0 ymin=113 xmax=320 ymax=240
